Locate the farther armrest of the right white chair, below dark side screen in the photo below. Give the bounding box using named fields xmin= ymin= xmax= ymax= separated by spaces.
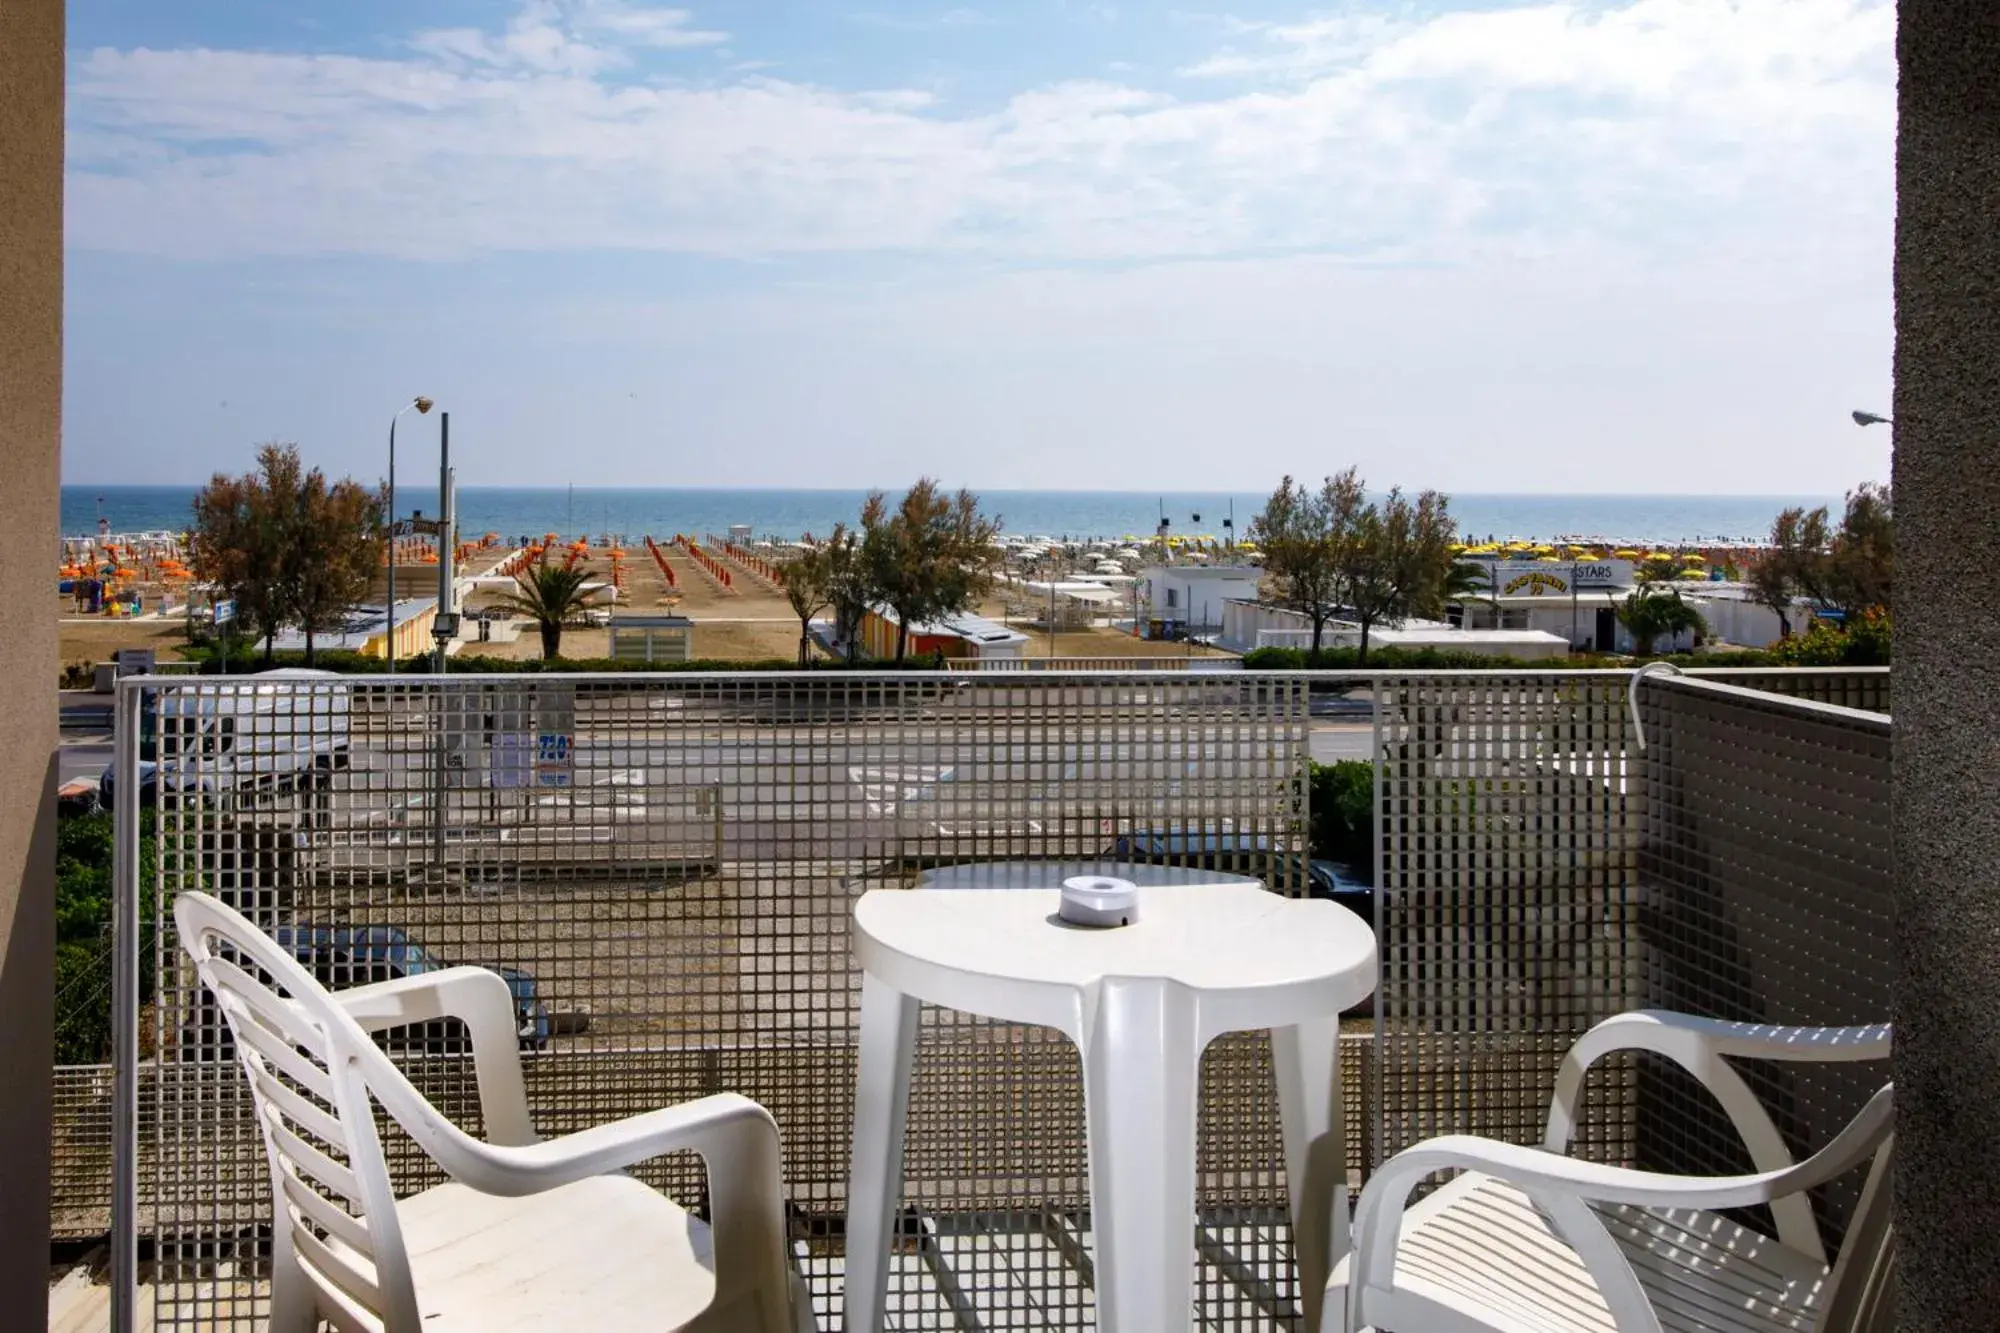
xmin=1542 ymin=1009 xmax=1890 ymax=1263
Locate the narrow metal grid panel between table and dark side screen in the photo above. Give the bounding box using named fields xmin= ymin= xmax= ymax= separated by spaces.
xmin=1374 ymin=673 xmax=1640 ymax=1161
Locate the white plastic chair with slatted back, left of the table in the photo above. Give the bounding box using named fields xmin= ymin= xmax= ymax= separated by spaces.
xmin=174 ymin=893 xmax=814 ymax=1333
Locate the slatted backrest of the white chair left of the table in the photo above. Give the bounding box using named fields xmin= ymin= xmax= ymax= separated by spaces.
xmin=174 ymin=880 xmax=420 ymax=1333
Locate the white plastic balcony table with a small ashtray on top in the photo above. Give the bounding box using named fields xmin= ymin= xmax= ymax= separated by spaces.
xmin=846 ymin=879 xmax=1376 ymax=1333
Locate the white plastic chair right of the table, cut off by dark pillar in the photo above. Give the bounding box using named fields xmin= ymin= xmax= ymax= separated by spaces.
xmin=1322 ymin=1011 xmax=1894 ymax=1333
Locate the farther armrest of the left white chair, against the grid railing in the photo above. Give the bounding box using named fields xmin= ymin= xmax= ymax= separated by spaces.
xmin=332 ymin=967 xmax=540 ymax=1147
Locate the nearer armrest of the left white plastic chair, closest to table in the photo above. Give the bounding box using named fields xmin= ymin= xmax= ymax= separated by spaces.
xmin=424 ymin=1093 xmax=790 ymax=1303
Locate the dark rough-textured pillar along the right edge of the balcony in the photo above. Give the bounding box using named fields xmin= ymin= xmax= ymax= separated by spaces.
xmin=1894 ymin=0 xmax=2000 ymax=1333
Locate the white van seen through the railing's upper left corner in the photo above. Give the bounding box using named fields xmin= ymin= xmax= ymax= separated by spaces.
xmin=98 ymin=667 xmax=352 ymax=809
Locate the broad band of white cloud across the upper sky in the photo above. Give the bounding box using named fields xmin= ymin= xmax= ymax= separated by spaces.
xmin=70 ymin=0 xmax=1894 ymax=264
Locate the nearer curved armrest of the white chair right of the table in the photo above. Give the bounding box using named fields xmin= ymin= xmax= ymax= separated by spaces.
xmin=1350 ymin=1087 xmax=1894 ymax=1301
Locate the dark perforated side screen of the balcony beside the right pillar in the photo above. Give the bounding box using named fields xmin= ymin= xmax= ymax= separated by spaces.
xmin=1638 ymin=677 xmax=1896 ymax=1239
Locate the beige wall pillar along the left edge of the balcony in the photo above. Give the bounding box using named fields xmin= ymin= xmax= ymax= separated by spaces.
xmin=0 ymin=0 xmax=62 ymax=1329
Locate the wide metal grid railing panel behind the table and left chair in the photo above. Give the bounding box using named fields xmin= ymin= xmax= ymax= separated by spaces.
xmin=120 ymin=673 xmax=1344 ymax=1329
